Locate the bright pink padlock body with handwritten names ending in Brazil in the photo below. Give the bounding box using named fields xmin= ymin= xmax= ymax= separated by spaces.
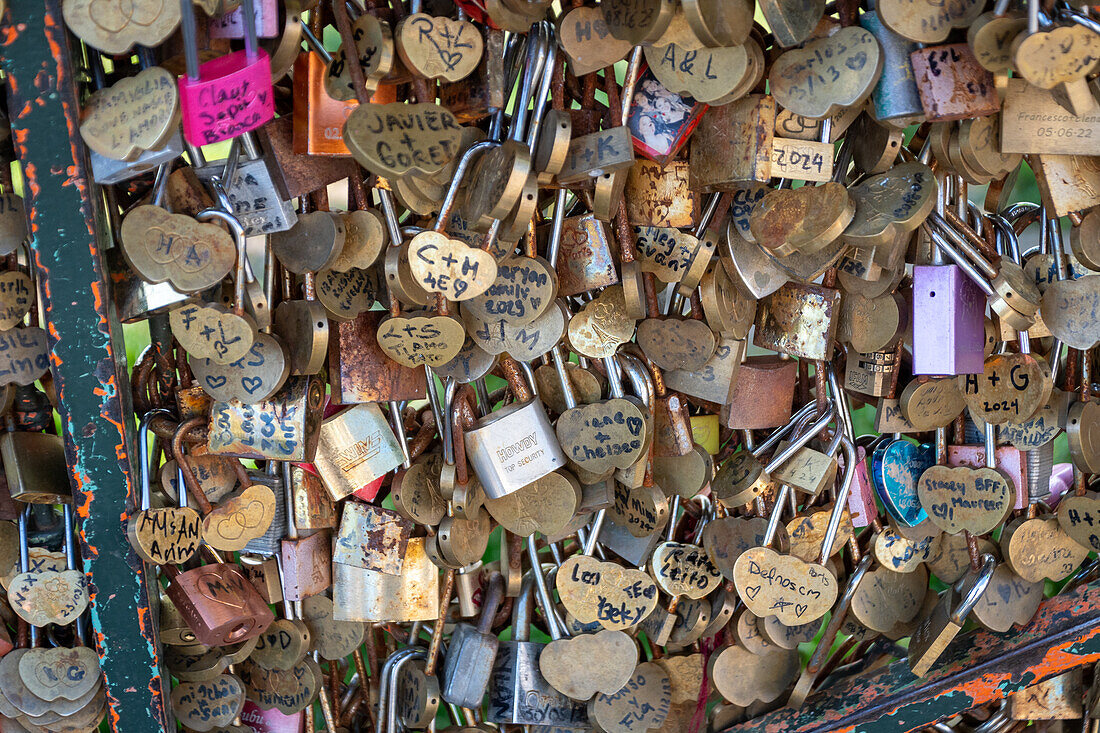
xmin=179 ymin=48 xmax=275 ymax=145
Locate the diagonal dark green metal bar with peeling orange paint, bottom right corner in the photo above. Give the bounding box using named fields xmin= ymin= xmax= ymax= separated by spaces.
xmin=726 ymin=581 xmax=1100 ymax=733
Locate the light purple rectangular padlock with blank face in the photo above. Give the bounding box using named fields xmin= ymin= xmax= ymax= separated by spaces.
xmin=912 ymin=265 xmax=986 ymax=375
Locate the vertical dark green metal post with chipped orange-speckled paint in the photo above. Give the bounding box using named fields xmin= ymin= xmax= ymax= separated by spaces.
xmin=0 ymin=0 xmax=168 ymax=733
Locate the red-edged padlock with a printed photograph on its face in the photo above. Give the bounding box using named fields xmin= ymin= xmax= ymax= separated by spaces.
xmin=627 ymin=66 xmax=707 ymax=163
